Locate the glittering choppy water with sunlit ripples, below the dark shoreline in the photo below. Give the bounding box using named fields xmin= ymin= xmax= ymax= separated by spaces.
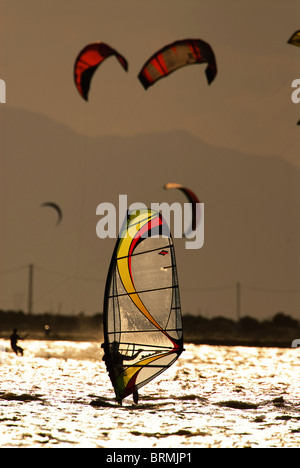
xmin=0 ymin=340 xmax=300 ymax=448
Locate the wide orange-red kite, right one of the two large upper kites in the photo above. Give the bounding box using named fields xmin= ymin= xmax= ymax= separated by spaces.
xmin=138 ymin=39 xmax=217 ymax=89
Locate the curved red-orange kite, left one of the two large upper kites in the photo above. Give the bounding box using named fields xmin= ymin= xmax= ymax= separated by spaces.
xmin=74 ymin=42 xmax=128 ymax=101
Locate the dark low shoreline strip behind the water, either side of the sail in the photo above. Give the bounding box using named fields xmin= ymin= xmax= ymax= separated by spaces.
xmin=0 ymin=310 xmax=300 ymax=348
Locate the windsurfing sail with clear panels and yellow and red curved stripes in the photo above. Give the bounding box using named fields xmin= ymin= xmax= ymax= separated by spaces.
xmin=102 ymin=209 xmax=183 ymax=403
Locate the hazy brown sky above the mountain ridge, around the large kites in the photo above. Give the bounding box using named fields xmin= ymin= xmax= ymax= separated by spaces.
xmin=0 ymin=0 xmax=300 ymax=163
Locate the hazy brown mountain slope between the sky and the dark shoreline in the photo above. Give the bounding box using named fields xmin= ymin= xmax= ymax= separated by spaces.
xmin=0 ymin=105 xmax=300 ymax=318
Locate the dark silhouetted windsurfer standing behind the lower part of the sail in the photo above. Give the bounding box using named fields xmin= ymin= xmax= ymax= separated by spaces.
xmin=101 ymin=341 xmax=143 ymax=404
